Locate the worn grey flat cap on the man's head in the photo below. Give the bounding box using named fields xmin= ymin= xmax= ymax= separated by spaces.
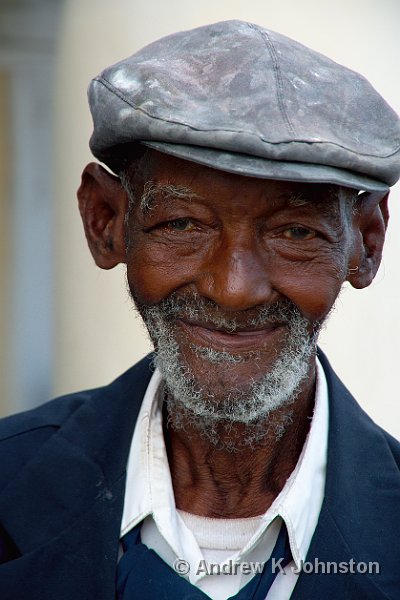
xmin=89 ymin=21 xmax=400 ymax=192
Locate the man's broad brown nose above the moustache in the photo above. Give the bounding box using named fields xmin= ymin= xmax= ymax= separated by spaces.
xmin=196 ymin=233 xmax=275 ymax=311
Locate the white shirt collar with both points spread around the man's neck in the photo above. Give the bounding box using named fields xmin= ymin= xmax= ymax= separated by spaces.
xmin=121 ymin=359 xmax=328 ymax=568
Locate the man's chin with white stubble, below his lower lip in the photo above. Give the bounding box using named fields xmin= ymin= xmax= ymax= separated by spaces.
xmin=156 ymin=336 xmax=311 ymax=427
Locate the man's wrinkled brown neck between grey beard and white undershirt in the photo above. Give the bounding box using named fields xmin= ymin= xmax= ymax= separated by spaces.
xmin=168 ymin=384 xmax=312 ymax=518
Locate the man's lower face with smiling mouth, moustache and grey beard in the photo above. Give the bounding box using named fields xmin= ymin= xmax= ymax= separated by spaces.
xmin=130 ymin=296 xmax=315 ymax=446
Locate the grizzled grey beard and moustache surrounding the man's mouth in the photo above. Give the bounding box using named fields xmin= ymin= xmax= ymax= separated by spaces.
xmin=135 ymin=295 xmax=319 ymax=450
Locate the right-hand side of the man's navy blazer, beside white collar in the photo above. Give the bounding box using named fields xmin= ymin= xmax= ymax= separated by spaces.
xmin=292 ymin=355 xmax=400 ymax=600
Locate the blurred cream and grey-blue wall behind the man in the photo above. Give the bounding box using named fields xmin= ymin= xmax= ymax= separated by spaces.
xmin=0 ymin=0 xmax=400 ymax=437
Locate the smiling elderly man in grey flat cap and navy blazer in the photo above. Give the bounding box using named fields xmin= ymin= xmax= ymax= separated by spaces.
xmin=0 ymin=21 xmax=400 ymax=600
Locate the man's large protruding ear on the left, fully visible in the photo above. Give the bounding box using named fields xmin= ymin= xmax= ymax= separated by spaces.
xmin=77 ymin=163 xmax=128 ymax=269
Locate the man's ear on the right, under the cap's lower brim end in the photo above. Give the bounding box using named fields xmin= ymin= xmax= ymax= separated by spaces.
xmin=347 ymin=192 xmax=389 ymax=289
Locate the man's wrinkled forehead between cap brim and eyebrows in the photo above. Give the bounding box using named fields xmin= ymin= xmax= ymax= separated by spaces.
xmin=121 ymin=150 xmax=359 ymax=224
